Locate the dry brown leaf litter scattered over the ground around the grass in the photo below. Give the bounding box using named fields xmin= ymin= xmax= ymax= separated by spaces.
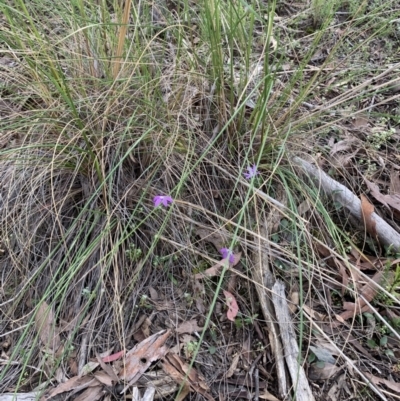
xmin=3 ymin=3 xmax=399 ymax=401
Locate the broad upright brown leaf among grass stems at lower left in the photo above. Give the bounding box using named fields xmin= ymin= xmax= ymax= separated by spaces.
xmin=35 ymin=301 xmax=61 ymax=354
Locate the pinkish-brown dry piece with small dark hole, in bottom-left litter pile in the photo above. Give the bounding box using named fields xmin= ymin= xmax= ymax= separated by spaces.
xmin=119 ymin=330 xmax=170 ymax=391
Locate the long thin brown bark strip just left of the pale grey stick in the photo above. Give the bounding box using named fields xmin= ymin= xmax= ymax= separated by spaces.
xmin=253 ymin=223 xmax=288 ymax=399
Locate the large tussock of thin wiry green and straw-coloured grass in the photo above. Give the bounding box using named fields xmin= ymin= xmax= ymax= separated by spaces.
xmin=0 ymin=1 xmax=398 ymax=396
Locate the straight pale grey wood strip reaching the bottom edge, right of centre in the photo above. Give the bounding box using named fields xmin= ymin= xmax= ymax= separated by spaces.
xmin=272 ymin=280 xmax=315 ymax=401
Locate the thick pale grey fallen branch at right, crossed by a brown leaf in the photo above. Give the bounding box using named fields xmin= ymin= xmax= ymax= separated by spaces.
xmin=293 ymin=157 xmax=400 ymax=251
